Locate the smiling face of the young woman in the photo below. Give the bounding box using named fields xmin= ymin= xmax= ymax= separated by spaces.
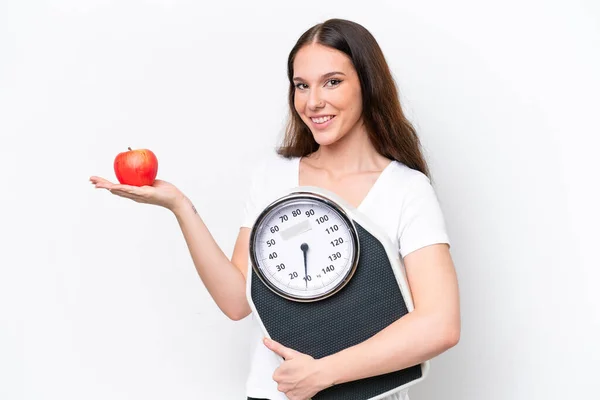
xmin=293 ymin=43 xmax=362 ymax=145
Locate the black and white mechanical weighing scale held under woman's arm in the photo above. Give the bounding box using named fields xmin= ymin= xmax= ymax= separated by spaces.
xmin=246 ymin=186 xmax=429 ymax=400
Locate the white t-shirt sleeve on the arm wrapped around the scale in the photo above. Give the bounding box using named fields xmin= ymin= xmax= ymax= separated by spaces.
xmin=398 ymin=174 xmax=450 ymax=258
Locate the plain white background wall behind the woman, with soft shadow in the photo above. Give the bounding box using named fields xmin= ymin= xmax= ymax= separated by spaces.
xmin=0 ymin=0 xmax=600 ymax=400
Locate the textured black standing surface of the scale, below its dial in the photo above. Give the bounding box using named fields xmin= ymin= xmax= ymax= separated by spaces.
xmin=251 ymin=222 xmax=422 ymax=400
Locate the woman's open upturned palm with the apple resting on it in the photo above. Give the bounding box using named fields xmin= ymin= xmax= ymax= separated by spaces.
xmin=90 ymin=176 xmax=185 ymax=211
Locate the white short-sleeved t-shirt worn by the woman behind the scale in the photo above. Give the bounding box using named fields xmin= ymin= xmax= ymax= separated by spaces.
xmin=242 ymin=154 xmax=450 ymax=400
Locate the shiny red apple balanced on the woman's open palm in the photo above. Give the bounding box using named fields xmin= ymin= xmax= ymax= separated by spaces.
xmin=114 ymin=147 xmax=158 ymax=186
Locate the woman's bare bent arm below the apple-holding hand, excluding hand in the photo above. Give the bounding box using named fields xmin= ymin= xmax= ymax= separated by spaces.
xmin=172 ymin=197 xmax=251 ymax=321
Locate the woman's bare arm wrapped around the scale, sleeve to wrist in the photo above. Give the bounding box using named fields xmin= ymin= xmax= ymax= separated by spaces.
xmin=318 ymin=244 xmax=460 ymax=384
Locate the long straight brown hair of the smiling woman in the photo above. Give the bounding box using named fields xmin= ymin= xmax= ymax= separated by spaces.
xmin=277 ymin=18 xmax=430 ymax=177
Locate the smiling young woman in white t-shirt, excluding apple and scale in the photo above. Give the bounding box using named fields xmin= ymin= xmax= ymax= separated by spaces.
xmin=90 ymin=19 xmax=460 ymax=400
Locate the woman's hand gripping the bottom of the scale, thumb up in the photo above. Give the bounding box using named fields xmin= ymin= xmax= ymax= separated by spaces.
xmin=264 ymin=338 xmax=333 ymax=400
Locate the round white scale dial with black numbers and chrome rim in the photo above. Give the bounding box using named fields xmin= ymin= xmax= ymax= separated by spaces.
xmin=250 ymin=192 xmax=359 ymax=301
